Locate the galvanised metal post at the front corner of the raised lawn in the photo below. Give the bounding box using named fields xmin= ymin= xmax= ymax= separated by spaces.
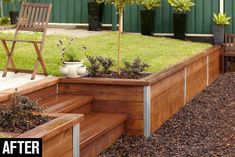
xmin=144 ymin=86 xmax=151 ymax=137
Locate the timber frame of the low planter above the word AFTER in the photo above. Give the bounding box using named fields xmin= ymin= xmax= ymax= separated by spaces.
xmin=0 ymin=113 xmax=83 ymax=157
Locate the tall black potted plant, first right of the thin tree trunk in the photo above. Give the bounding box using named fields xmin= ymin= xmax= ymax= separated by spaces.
xmin=140 ymin=0 xmax=161 ymax=35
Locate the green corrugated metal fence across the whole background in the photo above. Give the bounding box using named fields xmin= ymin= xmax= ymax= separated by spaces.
xmin=0 ymin=0 xmax=235 ymax=34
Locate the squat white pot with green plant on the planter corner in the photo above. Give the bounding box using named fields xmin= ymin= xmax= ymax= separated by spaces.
xmin=57 ymin=38 xmax=86 ymax=78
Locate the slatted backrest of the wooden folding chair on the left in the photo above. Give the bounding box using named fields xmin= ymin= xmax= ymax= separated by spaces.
xmin=16 ymin=2 xmax=52 ymax=32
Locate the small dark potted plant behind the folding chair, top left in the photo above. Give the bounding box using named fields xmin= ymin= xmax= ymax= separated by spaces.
xmin=4 ymin=0 xmax=26 ymax=25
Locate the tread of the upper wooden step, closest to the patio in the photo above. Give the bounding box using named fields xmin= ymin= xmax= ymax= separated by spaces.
xmin=40 ymin=95 xmax=93 ymax=112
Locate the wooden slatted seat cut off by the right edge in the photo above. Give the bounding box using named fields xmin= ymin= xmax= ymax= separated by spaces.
xmin=222 ymin=34 xmax=235 ymax=72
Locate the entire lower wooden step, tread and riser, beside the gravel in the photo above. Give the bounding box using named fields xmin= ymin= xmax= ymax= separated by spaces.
xmin=80 ymin=112 xmax=127 ymax=157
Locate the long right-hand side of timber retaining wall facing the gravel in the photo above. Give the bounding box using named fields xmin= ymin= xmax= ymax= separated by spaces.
xmin=144 ymin=46 xmax=223 ymax=131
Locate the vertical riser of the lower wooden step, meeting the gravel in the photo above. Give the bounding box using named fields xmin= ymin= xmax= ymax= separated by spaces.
xmin=80 ymin=123 xmax=125 ymax=157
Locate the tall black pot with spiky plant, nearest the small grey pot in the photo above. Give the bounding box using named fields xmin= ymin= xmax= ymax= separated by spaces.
xmin=168 ymin=0 xmax=195 ymax=39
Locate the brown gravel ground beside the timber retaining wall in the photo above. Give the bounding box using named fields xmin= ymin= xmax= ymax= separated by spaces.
xmin=99 ymin=73 xmax=235 ymax=157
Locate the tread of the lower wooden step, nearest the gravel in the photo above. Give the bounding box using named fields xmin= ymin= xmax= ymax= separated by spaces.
xmin=80 ymin=112 xmax=126 ymax=148
